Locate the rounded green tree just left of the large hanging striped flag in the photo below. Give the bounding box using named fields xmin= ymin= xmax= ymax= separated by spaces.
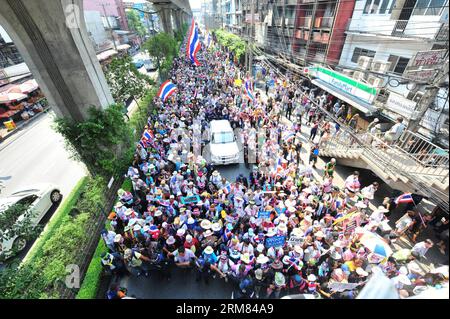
xmin=143 ymin=32 xmax=178 ymax=79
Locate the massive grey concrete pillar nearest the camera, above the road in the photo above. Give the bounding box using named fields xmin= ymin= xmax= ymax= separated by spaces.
xmin=0 ymin=0 xmax=114 ymax=121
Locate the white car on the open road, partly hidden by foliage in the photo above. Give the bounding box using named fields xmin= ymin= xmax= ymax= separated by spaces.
xmin=0 ymin=184 xmax=62 ymax=260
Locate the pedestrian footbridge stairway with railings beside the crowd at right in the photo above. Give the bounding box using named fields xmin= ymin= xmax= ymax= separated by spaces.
xmin=320 ymin=128 xmax=449 ymax=211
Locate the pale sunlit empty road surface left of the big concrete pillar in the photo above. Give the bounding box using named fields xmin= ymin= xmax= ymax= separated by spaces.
xmin=0 ymin=111 xmax=86 ymax=196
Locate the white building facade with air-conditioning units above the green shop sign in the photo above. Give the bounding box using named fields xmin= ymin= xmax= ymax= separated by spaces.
xmin=339 ymin=0 xmax=449 ymax=142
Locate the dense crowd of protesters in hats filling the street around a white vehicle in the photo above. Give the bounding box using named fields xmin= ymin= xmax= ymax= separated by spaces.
xmin=102 ymin=30 xmax=448 ymax=298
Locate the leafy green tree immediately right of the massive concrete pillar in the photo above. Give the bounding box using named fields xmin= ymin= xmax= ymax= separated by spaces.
xmin=105 ymin=56 xmax=154 ymax=104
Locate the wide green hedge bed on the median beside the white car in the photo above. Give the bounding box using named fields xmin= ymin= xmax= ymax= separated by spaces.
xmin=0 ymin=178 xmax=109 ymax=299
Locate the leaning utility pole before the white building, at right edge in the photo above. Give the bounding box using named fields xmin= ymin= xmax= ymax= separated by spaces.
xmin=408 ymin=55 xmax=449 ymax=132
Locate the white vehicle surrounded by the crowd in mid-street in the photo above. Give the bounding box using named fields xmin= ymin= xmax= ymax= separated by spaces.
xmin=209 ymin=120 xmax=239 ymax=165
